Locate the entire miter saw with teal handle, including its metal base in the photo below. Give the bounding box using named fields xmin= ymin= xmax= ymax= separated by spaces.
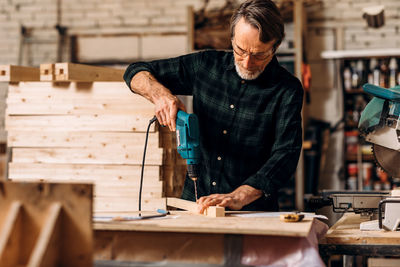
xmin=310 ymin=84 xmax=400 ymax=231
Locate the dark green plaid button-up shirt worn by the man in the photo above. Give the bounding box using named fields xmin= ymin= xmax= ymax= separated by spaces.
xmin=124 ymin=50 xmax=303 ymax=210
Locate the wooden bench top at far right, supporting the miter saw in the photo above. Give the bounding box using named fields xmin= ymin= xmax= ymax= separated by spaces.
xmin=319 ymin=213 xmax=400 ymax=266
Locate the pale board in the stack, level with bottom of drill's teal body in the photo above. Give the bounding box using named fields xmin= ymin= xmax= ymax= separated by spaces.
xmin=12 ymin=148 xmax=163 ymax=165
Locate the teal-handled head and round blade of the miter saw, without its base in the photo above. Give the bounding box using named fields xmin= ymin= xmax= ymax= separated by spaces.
xmin=358 ymin=83 xmax=400 ymax=178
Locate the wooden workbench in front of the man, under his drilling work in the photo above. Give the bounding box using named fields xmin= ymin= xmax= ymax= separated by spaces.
xmin=94 ymin=211 xmax=322 ymax=266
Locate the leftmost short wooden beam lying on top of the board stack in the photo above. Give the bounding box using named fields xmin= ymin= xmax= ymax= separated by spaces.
xmin=0 ymin=65 xmax=40 ymax=82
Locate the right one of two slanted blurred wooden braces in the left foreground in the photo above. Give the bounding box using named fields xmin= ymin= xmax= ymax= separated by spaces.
xmin=27 ymin=202 xmax=63 ymax=267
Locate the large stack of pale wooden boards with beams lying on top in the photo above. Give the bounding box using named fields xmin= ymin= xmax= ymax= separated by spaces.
xmin=0 ymin=63 xmax=186 ymax=213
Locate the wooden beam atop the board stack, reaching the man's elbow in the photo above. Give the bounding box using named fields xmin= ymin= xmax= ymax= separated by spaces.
xmin=55 ymin=63 xmax=125 ymax=82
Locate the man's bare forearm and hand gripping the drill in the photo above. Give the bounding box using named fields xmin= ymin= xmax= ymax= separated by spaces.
xmin=131 ymin=71 xmax=186 ymax=131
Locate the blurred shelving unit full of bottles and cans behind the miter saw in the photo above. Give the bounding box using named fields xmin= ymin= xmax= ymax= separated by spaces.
xmin=321 ymin=49 xmax=400 ymax=193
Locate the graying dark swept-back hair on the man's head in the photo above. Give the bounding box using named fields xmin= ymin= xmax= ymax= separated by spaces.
xmin=231 ymin=0 xmax=285 ymax=51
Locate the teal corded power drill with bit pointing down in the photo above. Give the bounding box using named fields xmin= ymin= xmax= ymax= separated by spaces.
xmin=176 ymin=110 xmax=200 ymax=201
